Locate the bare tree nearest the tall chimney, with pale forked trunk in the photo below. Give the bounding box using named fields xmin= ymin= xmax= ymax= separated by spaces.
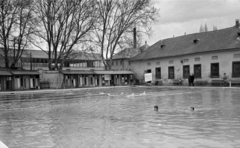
xmin=93 ymin=0 xmax=158 ymax=69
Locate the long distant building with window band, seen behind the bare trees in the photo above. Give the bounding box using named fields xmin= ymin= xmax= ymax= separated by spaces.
xmin=0 ymin=49 xmax=103 ymax=70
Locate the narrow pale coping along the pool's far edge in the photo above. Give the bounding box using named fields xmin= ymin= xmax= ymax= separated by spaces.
xmin=0 ymin=85 xmax=240 ymax=95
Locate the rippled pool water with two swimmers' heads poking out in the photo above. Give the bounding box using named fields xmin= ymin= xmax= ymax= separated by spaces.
xmin=0 ymin=87 xmax=240 ymax=148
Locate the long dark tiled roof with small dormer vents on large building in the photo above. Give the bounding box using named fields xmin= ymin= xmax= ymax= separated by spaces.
xmin=131 ymin=26 xmax=240 ymax=61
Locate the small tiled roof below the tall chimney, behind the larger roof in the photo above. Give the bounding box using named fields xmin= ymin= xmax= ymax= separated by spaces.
xmin=113 ymin=44 xmax=149 ymax=60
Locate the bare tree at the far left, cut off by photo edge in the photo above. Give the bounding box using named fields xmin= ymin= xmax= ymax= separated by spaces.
xmin=0 ymin=0 xmax=36 ymax=68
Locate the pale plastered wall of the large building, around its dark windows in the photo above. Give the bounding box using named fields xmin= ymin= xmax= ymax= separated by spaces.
xmin=131 ymin=49 xmax=240 ymax=82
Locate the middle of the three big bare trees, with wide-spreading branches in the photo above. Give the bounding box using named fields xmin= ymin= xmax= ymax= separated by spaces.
xmin=33 ymin=0 xmax=97 ymax=69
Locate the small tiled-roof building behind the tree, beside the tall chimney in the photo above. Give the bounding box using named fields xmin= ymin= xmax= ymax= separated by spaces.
xmin=112 ymin=42 xmax=149 ymax=70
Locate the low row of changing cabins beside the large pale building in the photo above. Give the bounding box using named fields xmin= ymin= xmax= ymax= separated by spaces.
xmin=60 ymin=70 xmax=134 ymax=88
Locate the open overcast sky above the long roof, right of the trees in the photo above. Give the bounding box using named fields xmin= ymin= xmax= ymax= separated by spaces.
xmin=144 ymin=0 xmax=240 ymax=45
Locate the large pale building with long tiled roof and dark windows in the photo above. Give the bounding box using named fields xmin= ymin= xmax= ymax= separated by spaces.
xmin=131 ymin=20 xmax=240 ymax=83
